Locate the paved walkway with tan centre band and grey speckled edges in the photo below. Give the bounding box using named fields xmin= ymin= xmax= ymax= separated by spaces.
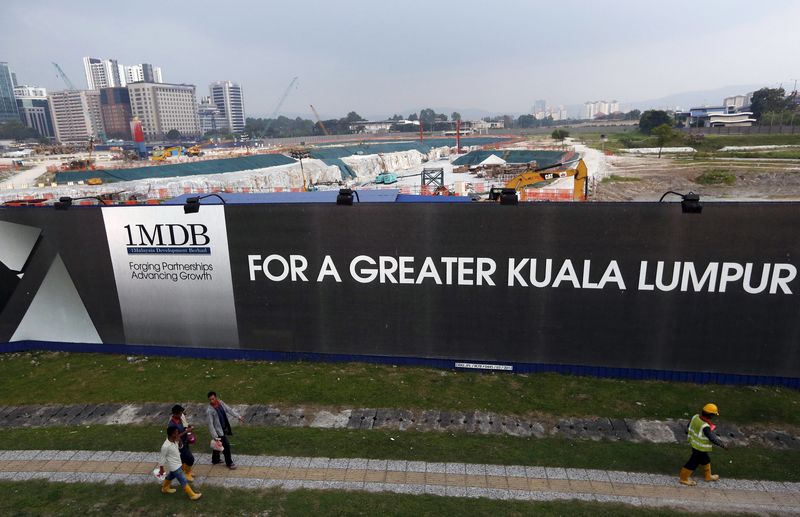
xmin=0 ymin=450 xmax=800 ymax=514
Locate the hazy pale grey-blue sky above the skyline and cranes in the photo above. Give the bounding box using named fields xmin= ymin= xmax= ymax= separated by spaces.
xmin=0 ymin=0 xmax=800 ymax=118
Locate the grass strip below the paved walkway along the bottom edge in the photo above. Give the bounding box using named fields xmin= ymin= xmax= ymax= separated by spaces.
xmin=0 ymin=480 xmax=703 ymax=517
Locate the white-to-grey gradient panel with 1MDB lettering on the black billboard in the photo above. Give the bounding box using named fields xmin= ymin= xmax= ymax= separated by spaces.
xmin=103 ymin=205 xmax=239 ymax=347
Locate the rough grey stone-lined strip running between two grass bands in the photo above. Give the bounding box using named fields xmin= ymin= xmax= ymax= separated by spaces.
xmin=0 ymin=403 xmax=800 ymax=450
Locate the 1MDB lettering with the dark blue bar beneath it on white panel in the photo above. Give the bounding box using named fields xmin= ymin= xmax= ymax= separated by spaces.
xmin=123 ymin=224 xmax=211 ymax=255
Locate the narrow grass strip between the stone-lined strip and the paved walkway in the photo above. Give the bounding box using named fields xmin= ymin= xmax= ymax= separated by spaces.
xmin=6 ymin=426 xmax=800 ymax=481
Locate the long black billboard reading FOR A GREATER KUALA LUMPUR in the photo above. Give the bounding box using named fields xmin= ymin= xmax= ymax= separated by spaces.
xmin=0 ymin=203 xmax=800 ymax=383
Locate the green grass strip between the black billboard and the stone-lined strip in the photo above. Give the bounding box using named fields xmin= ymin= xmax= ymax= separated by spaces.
xmin=6 ymin=352 xmax=800 ymax=426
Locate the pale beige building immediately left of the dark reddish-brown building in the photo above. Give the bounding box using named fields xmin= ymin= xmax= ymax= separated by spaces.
xmin=47 ymin=90 xmax=103 ymax=143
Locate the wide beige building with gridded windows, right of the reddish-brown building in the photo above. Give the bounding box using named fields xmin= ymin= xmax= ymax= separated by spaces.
xmin=128 ymin=82 xmax=201 ymax=140
